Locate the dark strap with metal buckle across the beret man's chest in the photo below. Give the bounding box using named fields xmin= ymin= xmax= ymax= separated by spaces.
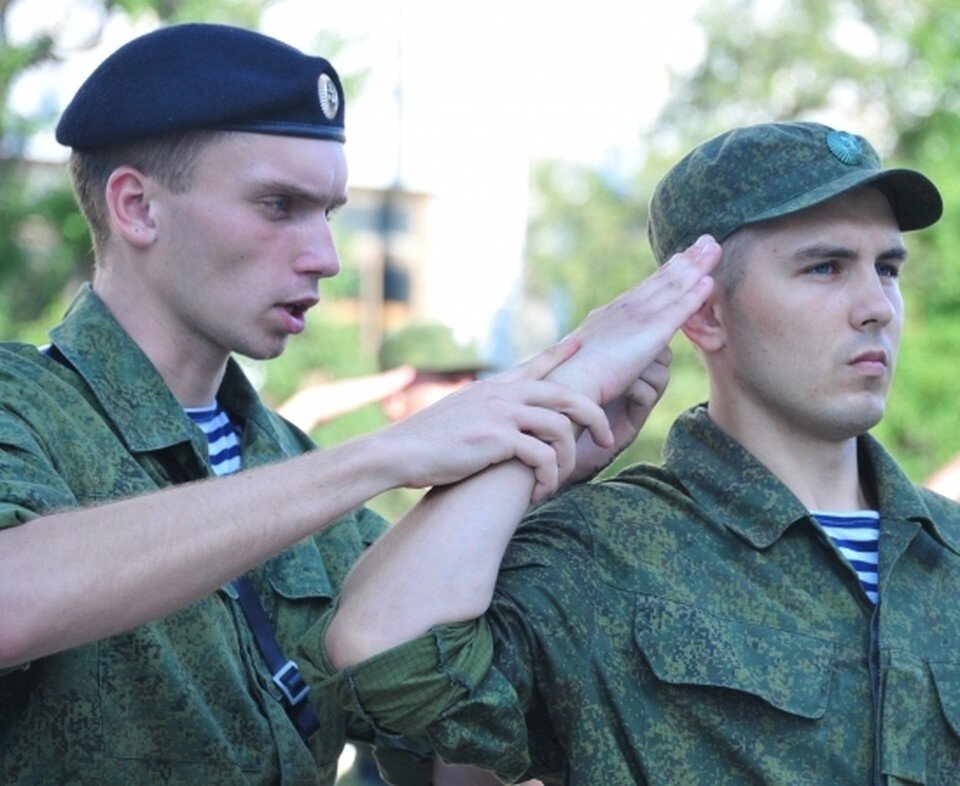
xmin=42 ymin=344 xmax=320 ymax=740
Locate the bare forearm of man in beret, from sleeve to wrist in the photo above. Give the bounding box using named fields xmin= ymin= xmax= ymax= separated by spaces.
xmin=0 ymin=428 xmax=395 ymax=667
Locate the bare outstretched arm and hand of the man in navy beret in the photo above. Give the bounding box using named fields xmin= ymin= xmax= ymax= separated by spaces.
xmin=0 ymin=356 xmax=607 ymax=668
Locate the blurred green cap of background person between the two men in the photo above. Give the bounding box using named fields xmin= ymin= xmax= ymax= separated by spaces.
xmin=377 ymin=323 xmax=489 ymax=374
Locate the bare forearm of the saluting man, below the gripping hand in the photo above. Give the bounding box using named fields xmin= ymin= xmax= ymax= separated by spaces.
xmin=326 ymin=461 xmax=534 ymax=669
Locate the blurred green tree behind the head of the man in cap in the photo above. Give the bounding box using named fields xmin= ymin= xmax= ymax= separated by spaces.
xmin=529 ymin=0 xmax=960 ymax=480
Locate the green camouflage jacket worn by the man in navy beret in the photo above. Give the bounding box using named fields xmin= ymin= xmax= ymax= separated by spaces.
xmin=0 ymin=290 xmax=428 ymax=786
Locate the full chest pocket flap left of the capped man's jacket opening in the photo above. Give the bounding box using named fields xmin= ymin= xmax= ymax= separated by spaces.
xmin=634 ymin=597 xmax=835 ymax=719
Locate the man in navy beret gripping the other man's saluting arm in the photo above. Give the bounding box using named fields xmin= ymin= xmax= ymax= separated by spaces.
xmin=0 ymin=25 xmax=716 ymax=786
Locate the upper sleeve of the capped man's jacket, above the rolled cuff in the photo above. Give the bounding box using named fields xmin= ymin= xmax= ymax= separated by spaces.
xmin=428 ymin=487 xmax=596 ymax=781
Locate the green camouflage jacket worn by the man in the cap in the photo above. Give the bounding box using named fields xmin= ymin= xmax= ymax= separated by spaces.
xmin=301 ymin=408 xmax=960 ymax=786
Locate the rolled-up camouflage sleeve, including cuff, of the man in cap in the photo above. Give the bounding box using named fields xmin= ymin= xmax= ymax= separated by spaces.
xmin=298 ymin=486 xmax=589 ymax=781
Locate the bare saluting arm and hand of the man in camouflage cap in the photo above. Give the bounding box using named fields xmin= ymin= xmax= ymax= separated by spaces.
xmin=326 ymin=238 xmax=720 ymax=668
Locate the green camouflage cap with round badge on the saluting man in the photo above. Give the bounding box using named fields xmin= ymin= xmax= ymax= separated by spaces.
xmin=647 ymin=123 xmax=943 ymax=264
